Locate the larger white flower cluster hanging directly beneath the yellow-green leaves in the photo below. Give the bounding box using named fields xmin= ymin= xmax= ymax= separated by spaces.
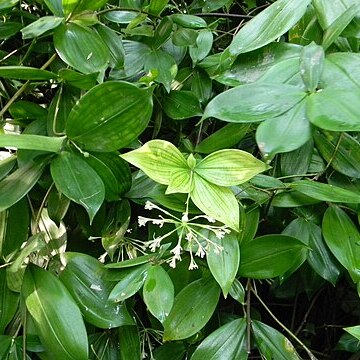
xmin=138 ymin=201 xmax=230 ymax=270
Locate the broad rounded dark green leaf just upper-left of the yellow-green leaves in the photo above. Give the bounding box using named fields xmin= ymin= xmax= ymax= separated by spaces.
xmin=66 ymin=81 xmax=153 ymax=152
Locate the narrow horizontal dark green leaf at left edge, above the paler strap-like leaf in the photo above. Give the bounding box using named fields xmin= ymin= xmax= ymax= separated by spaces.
xmin=0 ymin=66 xmax=57 ymax=81
